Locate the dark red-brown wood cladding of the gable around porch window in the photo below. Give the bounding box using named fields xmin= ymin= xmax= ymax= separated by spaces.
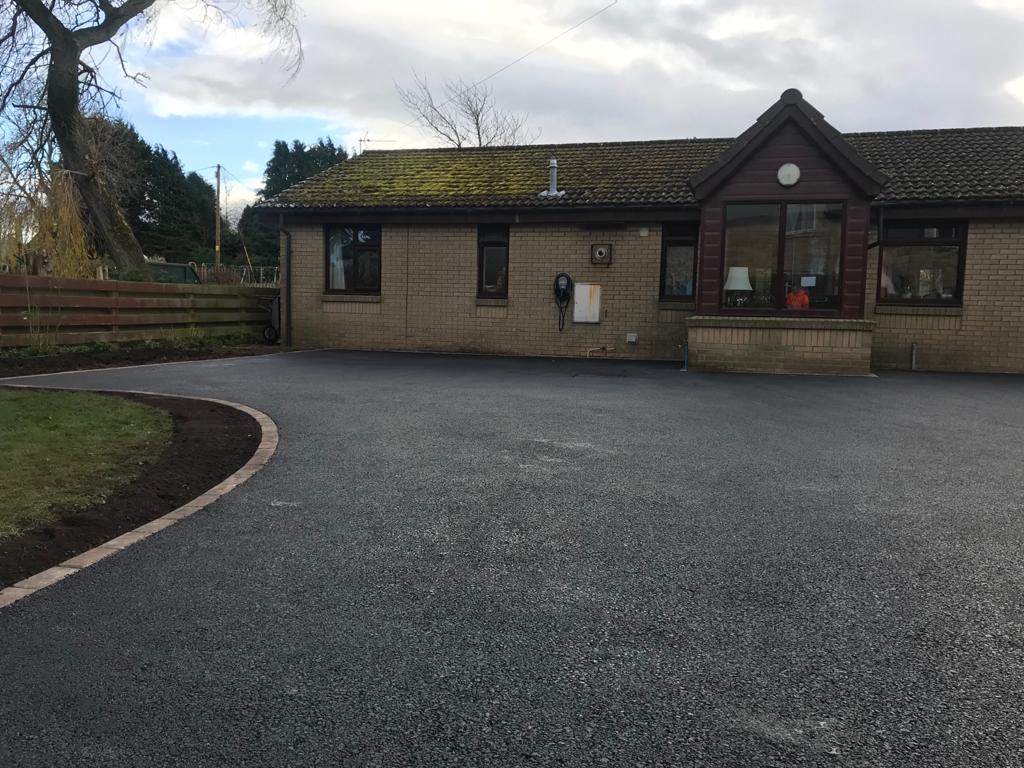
xmin=691 ymin=91 xmax=885 ymax=317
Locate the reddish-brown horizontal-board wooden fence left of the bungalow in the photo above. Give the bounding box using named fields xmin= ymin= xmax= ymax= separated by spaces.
xmin=0 ymin=274 xmax=278 ymax=347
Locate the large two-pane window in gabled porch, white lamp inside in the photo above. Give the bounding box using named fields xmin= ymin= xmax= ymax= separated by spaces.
xmin=722 ymin=203 xmax=844 ymax=312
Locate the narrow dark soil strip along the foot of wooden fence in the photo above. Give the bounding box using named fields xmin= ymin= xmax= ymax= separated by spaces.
xmin=0 ymin=344 xmax=281 ymax=379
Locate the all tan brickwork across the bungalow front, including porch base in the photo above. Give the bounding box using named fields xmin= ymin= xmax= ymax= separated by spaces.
xmin=290 ymin=220 xmax=1024 ymax=373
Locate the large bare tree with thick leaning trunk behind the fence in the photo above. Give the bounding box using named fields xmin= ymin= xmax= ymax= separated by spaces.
xmin=0 ymin=0 xmax=302 ymax=270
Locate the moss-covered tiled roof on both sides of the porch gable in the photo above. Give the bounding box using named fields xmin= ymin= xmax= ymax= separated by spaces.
xmin=262 ymin=127 xmax=1024 ymax=210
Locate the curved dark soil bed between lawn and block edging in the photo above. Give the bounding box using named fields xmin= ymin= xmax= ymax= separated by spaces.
xmin=0 ymin=394 xmax=261 ymax=588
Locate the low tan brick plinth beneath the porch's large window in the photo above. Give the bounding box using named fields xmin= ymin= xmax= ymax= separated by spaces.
xmin=688 ymin=315 xmax=874 ymax=375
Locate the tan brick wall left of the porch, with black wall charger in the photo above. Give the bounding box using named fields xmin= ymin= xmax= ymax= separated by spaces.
xmin=289 ymin=224 xmax=692 ymax=359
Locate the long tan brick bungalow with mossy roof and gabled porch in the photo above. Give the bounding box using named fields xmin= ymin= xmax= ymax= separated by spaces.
xmin=263 ymin=89 xmax=1024 ymax=374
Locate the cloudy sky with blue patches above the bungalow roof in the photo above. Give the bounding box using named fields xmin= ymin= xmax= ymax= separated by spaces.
xmin=109 ymin=0 xmax=1024 ymax=207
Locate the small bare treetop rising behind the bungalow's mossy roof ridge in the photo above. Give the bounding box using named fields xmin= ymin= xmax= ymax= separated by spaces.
xmin=395 ymin=75 xmax=538 ymax=147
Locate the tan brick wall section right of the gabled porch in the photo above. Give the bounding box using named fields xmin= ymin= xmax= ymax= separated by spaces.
xmin=864 ymin=220 xmax=1024 ymax=373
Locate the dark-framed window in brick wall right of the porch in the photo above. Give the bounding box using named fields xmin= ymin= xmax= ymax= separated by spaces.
xmin=879 ymin=221 xmax=967 ymax=304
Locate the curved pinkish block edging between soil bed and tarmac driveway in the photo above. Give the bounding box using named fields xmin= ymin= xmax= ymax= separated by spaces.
xmin=0 ymin=391 xmax=279 ymax=609
